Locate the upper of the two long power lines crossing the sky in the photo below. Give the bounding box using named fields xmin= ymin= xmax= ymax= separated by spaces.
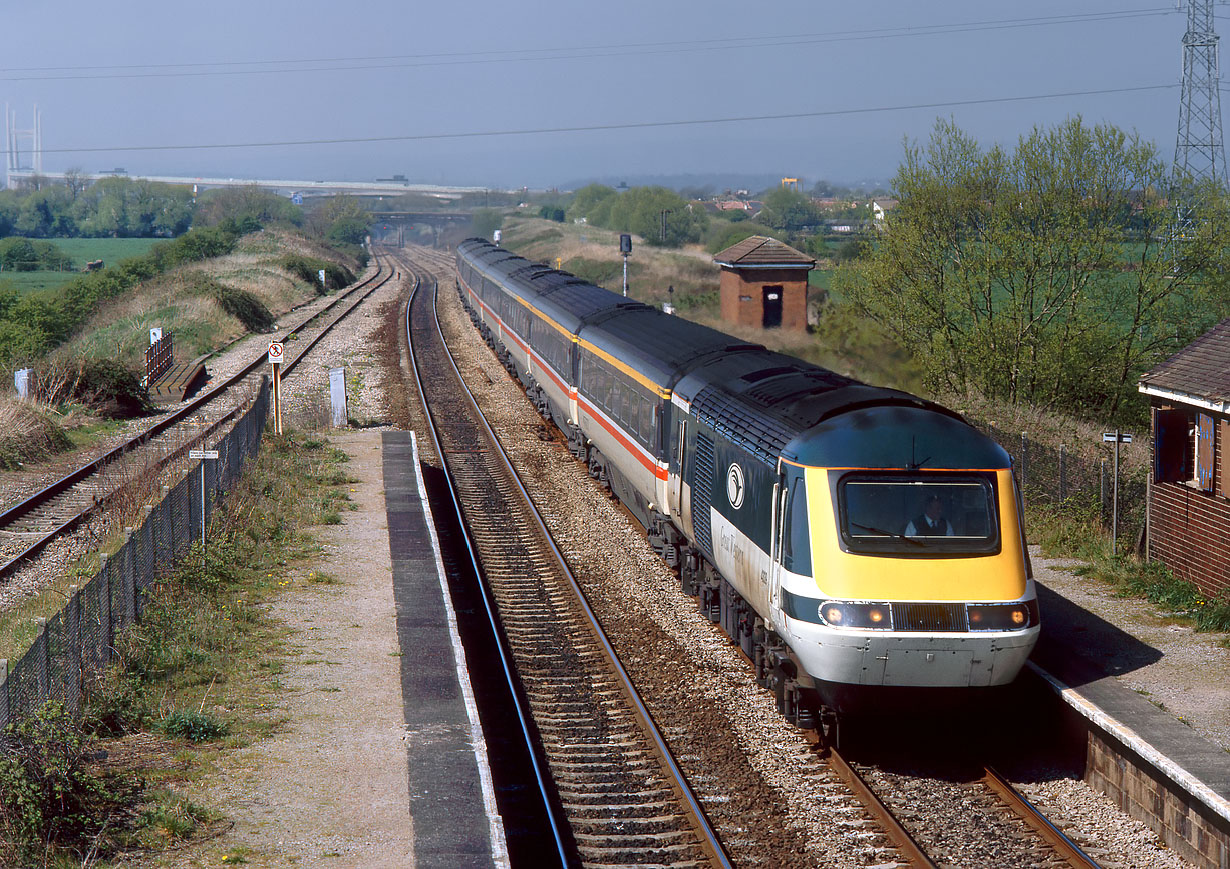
xmin=0 ymin=7 xmax=1173 ymax=81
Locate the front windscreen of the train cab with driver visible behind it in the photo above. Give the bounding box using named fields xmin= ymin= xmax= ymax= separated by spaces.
xmin=838 ymin=474 xmax=1000 ymax=557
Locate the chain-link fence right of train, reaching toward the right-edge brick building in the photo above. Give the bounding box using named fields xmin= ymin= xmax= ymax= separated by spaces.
xmin=969 ymin=419 xmax=1149 ymax=542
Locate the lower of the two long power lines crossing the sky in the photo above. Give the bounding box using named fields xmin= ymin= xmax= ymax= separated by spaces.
xmin=11 ymin=84 xmax=1178 ymax=154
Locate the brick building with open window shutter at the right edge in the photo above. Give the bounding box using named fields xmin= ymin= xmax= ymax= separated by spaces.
xmin=1140 ymin=320 xmax=1230 ymax=596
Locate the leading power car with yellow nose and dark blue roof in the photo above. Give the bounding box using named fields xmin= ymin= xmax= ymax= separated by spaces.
xmin=672 ymin=366 xmax=1039 ymax=724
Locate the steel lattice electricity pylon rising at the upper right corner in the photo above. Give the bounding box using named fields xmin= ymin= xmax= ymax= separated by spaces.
xmin=1175 ymin=0 xmax=1226 ymax=183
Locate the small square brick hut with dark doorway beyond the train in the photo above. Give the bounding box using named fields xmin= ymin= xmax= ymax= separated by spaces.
xmin=713 ymin=235 xmax=815 ymax=332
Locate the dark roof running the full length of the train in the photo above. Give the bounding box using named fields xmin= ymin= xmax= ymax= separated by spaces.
xmin=458 ymin=238 xmax=1011 ymax=468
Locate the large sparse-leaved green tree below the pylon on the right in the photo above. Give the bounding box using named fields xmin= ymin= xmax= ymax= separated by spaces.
xmin=835 ymin=118 xmax=1230 ymax=420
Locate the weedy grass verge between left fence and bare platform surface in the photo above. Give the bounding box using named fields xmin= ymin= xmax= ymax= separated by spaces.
xmin=0 ymin=433 xmax=351 ymax=867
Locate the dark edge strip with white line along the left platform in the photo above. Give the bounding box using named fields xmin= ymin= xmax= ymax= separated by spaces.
xmin=381 ymin=431 xmax=508 ymax=867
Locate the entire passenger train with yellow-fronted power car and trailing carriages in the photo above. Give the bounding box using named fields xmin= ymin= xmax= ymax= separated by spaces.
xmin=456 ymin=238 xmax=1038 ymax=726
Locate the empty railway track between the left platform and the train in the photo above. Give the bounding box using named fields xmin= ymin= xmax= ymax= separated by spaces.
xmin=408 ymin=254 xmax=729 ymax=867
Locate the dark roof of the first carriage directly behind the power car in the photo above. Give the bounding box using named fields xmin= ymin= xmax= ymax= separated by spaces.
xmin=579 ymin=306 xmax=764 ymax=390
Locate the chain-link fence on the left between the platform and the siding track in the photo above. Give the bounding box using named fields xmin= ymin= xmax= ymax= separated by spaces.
xmin=0 ymin=379 xmax=269 ymax=729
